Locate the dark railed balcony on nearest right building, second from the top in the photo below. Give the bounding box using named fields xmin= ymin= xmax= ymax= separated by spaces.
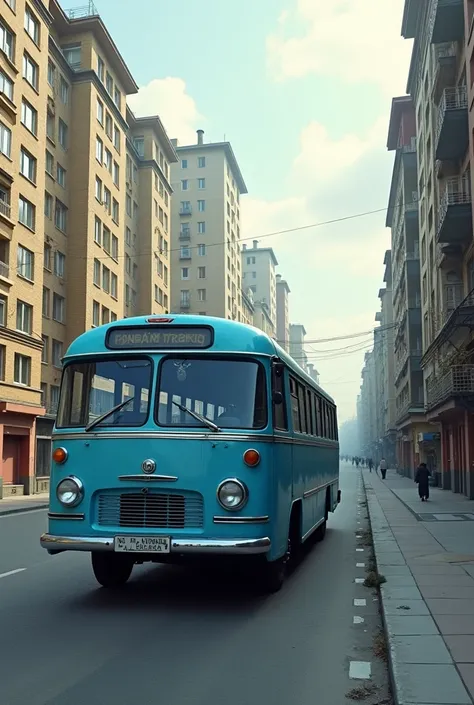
xmin=436 ymin=86 xmax=469 ymax=161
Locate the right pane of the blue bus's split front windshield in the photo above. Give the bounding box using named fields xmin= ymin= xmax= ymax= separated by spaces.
xmin=157 ymin=357 xmax=267 ymax=428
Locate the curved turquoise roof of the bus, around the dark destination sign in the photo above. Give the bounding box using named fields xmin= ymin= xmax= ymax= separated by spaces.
xmin=64 ymin=314 xmax=335 ymax=404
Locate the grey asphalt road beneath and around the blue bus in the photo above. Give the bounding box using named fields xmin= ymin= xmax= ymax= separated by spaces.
xmin=0 ymin=466 xmax=387 ymax=705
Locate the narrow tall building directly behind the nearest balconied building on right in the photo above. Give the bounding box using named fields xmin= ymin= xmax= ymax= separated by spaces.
xmin=386 ymin=96 xmax=432 ymax=475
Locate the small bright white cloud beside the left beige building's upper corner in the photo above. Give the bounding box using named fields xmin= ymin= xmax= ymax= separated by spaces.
xmin=128 ymin=77 xmax=203 ymax=144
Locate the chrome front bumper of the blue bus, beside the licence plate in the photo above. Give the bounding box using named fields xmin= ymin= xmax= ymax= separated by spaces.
xmin=40 ymin=534 xmax=271 ymax=556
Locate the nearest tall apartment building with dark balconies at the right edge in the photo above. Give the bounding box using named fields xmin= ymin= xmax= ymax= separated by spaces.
xmin=402 ymin=0 xmax=474 ymax=497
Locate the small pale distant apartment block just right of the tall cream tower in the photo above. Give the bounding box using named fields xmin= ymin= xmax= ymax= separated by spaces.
xmin=242 ymin=240 xmax=278 ymax=336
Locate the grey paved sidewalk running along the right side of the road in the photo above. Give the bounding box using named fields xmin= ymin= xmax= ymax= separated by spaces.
xmin=362 ymin=468 xmax=474 ymax=705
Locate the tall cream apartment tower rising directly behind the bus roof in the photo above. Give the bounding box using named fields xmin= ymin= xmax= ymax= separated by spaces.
xmin=171 ymin=130 xmax=247 ymax=321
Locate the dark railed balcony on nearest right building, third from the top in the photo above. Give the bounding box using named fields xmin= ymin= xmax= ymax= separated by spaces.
xmin=436 ymin=176 xmax=472 ymax=245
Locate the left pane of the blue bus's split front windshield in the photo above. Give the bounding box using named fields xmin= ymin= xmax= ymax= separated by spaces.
xmin=56 ymin=357 xmax=153 ymax=428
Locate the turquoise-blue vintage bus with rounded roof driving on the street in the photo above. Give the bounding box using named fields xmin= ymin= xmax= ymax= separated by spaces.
xmin=41 ymin=315 xmax=340 ymax=592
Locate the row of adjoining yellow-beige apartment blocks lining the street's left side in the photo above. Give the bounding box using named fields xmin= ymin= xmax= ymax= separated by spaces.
xmin=0 ymin=0 xmax=177 ymax=499
